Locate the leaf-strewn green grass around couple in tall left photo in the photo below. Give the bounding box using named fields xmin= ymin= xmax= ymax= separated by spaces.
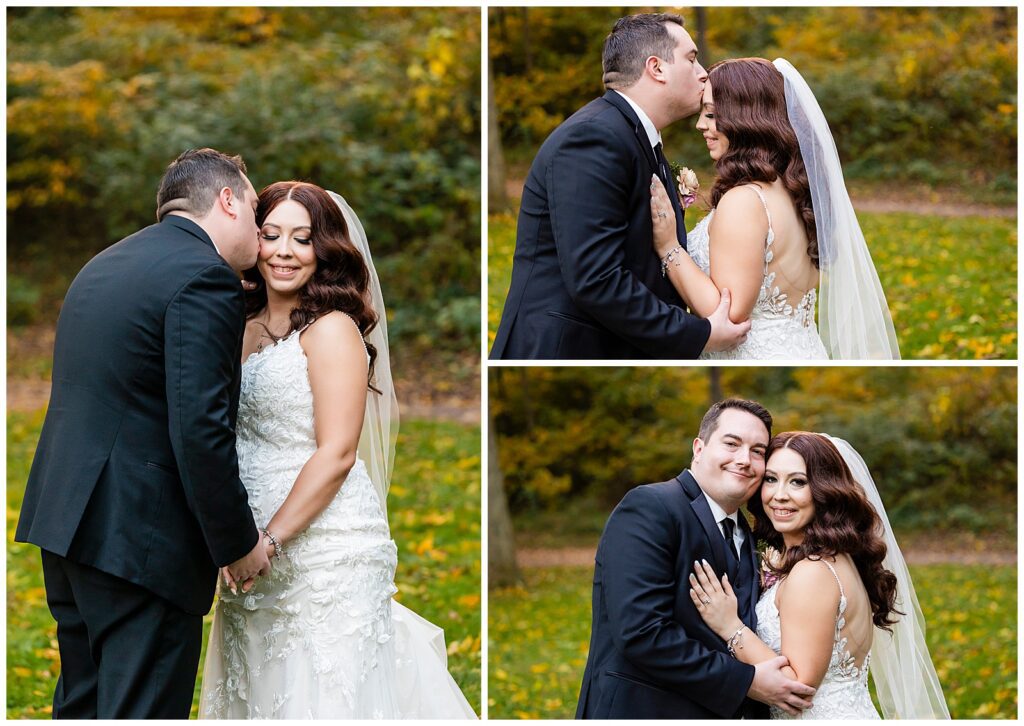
xmin=7 ymin=412 xmax=480 ymax=719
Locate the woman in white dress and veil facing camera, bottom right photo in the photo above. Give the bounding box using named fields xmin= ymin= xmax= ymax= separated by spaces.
xmin=690 ymin=431 xmax=949 ymax=719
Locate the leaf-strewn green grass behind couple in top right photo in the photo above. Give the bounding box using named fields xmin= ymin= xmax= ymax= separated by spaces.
xmin=487 ymin=206 xmax=1017 ymax=359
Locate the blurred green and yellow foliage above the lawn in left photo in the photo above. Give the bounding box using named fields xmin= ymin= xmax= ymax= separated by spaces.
xmin=7 ymin=7 xmax=480 ymax=351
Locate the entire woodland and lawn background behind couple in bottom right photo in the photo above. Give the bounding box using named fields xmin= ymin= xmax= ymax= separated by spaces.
xmin=487 ymin=367 xmax=1018 ymax=718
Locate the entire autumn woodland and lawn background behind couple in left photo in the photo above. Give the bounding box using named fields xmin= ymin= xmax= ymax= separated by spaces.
xmin=6 ymin=7 xmax=481 ymax=719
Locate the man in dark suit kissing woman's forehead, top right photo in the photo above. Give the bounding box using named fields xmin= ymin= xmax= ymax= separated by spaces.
xmin=490 ymin=13 xmax=750 ymax=358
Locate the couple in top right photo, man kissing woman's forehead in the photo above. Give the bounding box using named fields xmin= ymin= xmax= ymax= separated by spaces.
xmin=490 ymin=13 xmax=899 ymax=359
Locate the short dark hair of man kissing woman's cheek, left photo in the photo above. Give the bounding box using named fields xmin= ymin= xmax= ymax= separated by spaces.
xmin=157 ymin=148 xmax=246 ymax=222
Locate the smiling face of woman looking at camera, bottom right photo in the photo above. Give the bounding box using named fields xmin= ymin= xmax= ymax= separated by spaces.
xmin=761 ymin=449 xmax=814 ymax=547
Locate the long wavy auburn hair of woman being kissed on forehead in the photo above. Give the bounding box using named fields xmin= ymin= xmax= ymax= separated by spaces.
xmin=708 ymin=58 xmax=820 ymax=267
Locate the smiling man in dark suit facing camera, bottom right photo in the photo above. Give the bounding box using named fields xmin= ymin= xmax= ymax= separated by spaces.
xmin=577 ymin=398 xmax=814 ymax=719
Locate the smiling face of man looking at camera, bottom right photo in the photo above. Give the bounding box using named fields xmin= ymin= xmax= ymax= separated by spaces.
xmin=691 ymin=409 xmax=769 ymax=511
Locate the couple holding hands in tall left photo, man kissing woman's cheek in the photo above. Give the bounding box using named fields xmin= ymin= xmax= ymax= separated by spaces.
xmin=15 ymin=148 xmax=476 ymax=720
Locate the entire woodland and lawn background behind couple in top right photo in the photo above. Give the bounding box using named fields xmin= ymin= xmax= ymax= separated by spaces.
xmin=487 ymin=7 xmax=1018 ymax=358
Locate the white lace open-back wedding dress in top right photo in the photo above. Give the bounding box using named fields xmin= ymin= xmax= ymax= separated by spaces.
xmin=686 ymin=185 xmax=828 ymax=360
